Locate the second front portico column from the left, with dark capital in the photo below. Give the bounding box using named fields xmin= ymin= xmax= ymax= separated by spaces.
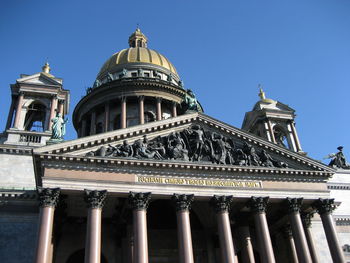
xmin=84 ymin=189 xmax=107 ymax=263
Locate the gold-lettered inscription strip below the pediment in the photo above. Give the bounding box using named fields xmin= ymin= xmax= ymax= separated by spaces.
xmin=137 ymin=176 xmax=262 ymax=188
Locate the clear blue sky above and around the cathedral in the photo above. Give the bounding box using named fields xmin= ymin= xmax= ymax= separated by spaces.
xmin=0 ymin=0 xmax=350 ymax=161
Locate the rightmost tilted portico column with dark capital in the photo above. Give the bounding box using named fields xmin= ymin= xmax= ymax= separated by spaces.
xmin=314 ymin=198 xmax=345 ymax=263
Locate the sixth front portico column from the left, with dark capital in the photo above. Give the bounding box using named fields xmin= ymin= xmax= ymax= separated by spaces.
xmin=248 ymin=196 xmax=276 ymax=263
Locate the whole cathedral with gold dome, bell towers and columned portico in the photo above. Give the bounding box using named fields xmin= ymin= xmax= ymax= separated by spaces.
xmin=0 ymin=29 xmax=350 ymax=263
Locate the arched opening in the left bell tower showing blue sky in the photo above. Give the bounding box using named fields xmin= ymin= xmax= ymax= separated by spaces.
xmin=24 ymin=102 xmax=46 ymax=132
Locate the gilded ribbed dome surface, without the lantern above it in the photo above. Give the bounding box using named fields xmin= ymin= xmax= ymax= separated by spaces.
xmin=98 ymin=47 xmax=177 ymax=76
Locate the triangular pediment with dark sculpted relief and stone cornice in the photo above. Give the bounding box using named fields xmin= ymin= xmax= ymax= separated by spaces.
xmin=34 ymin=113 xmax=334 ymax=176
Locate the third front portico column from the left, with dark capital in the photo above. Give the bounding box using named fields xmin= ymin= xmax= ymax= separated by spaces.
xmin=129 ymin=192 xmax=151 ymax=263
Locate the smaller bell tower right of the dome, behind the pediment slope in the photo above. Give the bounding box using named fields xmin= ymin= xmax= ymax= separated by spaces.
xmin=242 ymin=88 xmax=305 ymax=154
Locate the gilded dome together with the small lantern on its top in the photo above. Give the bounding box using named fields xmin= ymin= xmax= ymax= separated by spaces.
xmin=97 ymin=28 xmax=177 ymax=78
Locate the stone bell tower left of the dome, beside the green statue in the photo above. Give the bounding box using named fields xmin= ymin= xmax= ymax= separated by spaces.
xmin=2 ymin=62 xmax=69 ymax=146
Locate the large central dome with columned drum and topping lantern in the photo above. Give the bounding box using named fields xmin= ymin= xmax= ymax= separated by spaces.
xmin=73 ymin=28 xmax=202 ymax=137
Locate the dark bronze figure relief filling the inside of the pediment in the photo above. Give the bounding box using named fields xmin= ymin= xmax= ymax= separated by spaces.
xmin=86 ymin=124 xmax=288 ymax=168
